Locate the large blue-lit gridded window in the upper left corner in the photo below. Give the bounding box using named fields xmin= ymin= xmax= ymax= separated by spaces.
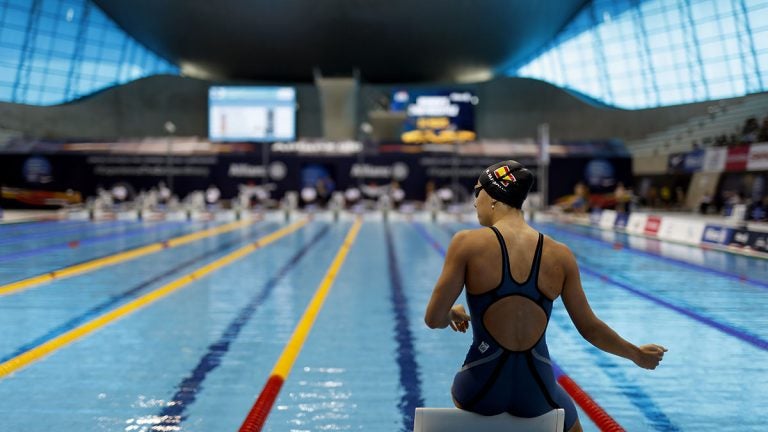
xmin=0 ymin=0 xmax=179 ymax=105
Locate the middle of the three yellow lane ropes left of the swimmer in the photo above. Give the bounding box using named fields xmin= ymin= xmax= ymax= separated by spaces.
xmin=0 ymin=219 xmax=307 ymax=378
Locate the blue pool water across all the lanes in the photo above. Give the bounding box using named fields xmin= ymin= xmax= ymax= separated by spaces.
xmin=0 ymin=221 xmax=768 ymax=432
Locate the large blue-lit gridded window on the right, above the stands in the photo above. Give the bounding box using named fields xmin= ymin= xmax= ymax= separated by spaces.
xmin=510 ymin=0 xmax=768 ymax=108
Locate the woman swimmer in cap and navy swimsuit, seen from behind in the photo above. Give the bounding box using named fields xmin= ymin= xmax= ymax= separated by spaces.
xmin=424 ymin=160 xmax=667 ymax=431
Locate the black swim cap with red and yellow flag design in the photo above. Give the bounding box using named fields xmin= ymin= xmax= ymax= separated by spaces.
xmin=478 ymin=159 xmax=534 ymax=209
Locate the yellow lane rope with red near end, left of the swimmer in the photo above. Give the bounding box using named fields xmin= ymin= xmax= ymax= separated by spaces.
xmin=240 ymin=219 xmax=362 ymax=432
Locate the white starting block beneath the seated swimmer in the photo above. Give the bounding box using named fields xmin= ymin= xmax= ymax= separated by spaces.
xmin=413 ymin=408 xmax=565 ymax=432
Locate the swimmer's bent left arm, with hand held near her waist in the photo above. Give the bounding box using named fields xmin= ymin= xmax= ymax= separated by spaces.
xmin=424 ymin=231 xmax=470 ymax=332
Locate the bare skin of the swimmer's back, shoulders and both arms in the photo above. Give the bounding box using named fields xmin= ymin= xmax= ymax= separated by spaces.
xmin=450 ymin=218 xmax=667 ymax=369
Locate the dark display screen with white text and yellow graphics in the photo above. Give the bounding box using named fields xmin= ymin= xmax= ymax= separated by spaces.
xmin=390 ymin=89 xmax=478 ymax=144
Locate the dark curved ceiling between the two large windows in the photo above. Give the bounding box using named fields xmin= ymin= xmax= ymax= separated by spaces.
xmin=94 ymin=0 xmax=588 ymax=82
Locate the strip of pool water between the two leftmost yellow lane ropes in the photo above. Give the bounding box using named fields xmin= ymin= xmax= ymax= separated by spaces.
xmin=0 ymin=224 xmax=276 ymax=361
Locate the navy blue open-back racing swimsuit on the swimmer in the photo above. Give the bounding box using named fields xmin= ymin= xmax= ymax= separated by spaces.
xmin=451 ymin=227 xmax=577 ymax=430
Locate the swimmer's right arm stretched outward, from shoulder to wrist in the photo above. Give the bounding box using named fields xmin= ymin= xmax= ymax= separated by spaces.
xmin=561 ymin=247 xmax=641 ymax=363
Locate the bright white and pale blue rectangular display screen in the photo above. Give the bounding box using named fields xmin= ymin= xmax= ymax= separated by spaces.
xmin=208 ymin=86 xmax=296 ymax=141
